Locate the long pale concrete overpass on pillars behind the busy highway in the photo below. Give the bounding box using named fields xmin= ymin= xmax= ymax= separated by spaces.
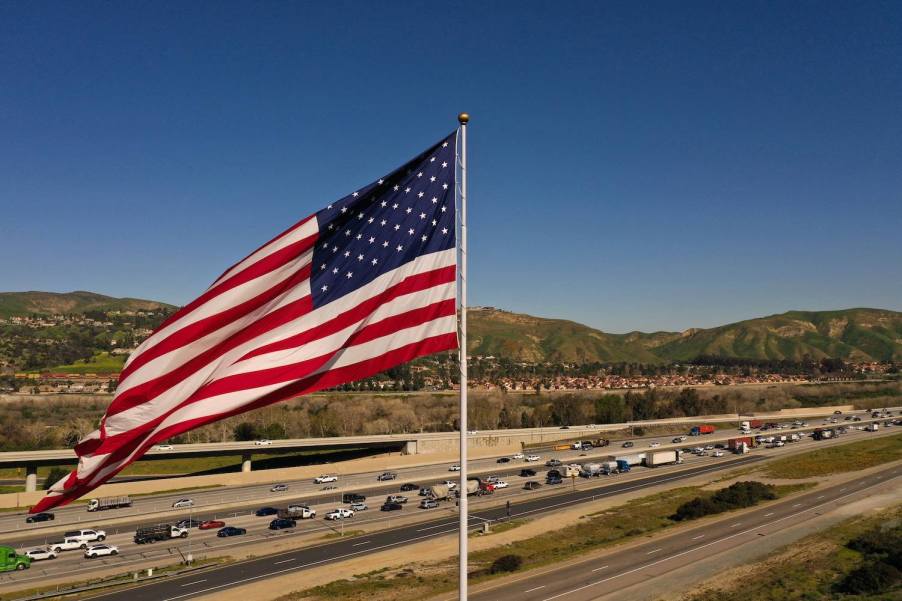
xmin=0 ymin=405 xmax=853 ymax=492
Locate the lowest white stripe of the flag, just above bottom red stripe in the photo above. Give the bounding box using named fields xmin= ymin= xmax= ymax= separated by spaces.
xmin=79 ymin=315 xmax=457 ymax=485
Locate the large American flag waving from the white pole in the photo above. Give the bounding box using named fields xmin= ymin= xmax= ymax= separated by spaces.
xmin=31 ymin=132 xmax=457 ymax=513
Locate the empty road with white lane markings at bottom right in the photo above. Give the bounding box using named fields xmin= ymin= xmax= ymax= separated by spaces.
xmin=469 ymin=466 xmax=902 ymax=601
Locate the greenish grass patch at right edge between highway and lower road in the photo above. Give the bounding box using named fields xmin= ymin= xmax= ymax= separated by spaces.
xmin=763 ymin=433 xmax=902 ymax=478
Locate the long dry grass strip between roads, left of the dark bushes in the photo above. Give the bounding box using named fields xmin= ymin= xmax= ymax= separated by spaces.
xmin=278 ymin=484 xmax=813 ymax=601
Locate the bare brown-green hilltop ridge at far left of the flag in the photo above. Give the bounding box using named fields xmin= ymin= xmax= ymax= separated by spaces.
xmin=0 ymin=291 xmax=175 ymax=317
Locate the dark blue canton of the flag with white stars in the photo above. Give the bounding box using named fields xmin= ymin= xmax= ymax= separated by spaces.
xmin=311 ymin=132 xmax=457 ymax=307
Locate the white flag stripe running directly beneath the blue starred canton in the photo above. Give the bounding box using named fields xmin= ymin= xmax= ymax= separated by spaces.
xmin=104 ymin=249 xmax=456 ymax=436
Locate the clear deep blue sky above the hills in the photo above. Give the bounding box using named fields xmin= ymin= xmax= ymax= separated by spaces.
xmin=0 ymin=2 xmax=902 ymax=332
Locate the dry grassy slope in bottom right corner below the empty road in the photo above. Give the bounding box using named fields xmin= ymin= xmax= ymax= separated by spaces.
xmin=680 ymin=506 xmax=902 ymax=601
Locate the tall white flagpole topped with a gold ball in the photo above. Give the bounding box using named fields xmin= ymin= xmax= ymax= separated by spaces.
xmin=457 ymin=113 xmax=470 ymax=601
